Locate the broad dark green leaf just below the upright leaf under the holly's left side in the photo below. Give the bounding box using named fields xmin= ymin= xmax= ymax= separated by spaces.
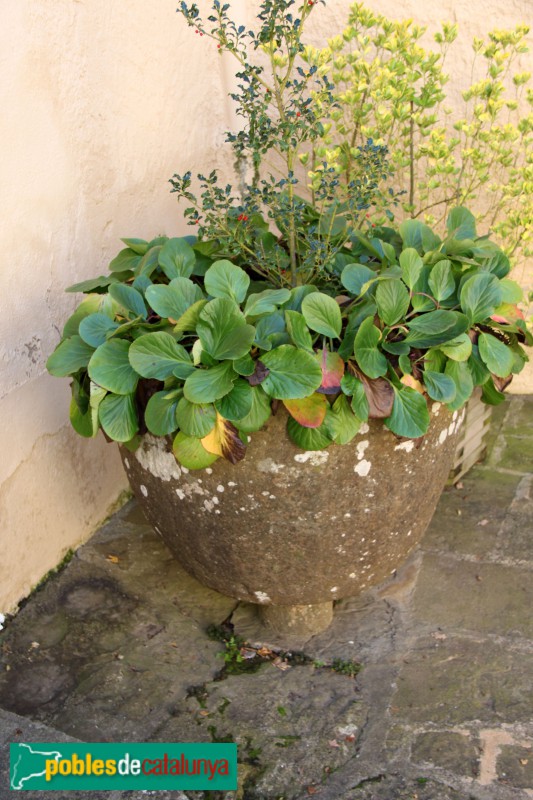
xmin=196 ymin=298 xmax=255 ymax=361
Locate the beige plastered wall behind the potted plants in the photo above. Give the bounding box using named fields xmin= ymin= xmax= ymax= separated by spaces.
xmin=0 ymin=0 xmax=531 ymax=613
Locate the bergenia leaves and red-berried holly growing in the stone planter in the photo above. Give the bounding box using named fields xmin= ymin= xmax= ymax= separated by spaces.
xmin=47 ymin=0 xmax=531 ymax=469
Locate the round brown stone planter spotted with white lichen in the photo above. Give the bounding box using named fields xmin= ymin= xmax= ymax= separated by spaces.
xmin=121 ymin=404 xmax=462 ymax=629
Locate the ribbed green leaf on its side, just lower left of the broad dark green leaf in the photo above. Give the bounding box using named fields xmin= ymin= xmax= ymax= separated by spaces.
xmin=129 ymin=331 xmax=194 ymax=381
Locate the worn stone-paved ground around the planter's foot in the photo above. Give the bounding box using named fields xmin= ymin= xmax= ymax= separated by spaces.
xmin=0 ymin=397 xmax=533 ymax=800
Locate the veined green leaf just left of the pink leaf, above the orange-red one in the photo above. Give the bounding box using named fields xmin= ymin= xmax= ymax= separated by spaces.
xmin=261 ymin=344 xmax=322 ymax=400
